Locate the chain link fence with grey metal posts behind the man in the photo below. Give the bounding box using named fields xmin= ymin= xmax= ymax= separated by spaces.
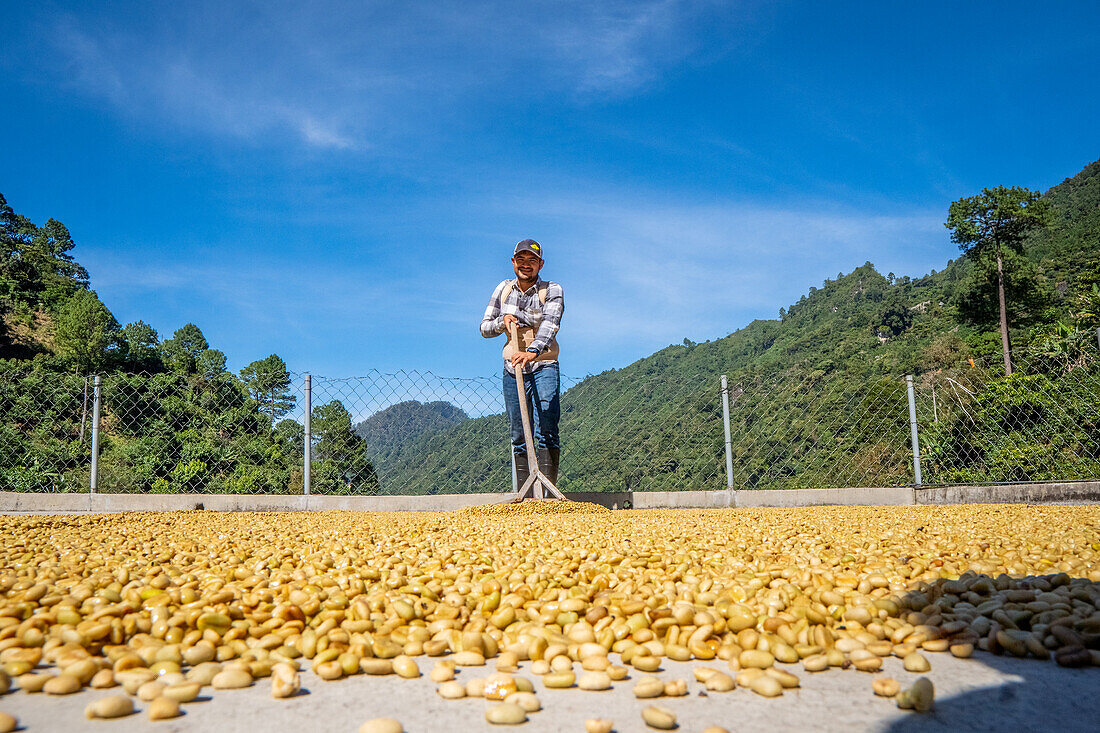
xmin=0 ymin=359 xmax=1100 ymax=495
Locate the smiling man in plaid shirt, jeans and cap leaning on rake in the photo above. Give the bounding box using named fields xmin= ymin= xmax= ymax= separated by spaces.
xmin=482 ymin=239 xmax=565 ymax=486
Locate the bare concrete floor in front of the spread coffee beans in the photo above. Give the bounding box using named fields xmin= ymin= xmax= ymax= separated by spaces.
xmin=0 ymin=653 xmax=1100 ymax=733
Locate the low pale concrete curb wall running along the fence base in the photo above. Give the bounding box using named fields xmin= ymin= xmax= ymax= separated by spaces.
xmin=0 ymin=481 xmax=1100 ymax=514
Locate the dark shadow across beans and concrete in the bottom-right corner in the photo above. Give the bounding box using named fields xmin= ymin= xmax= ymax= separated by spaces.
xmin=887 ymin=573 xmax=1100 ymax=733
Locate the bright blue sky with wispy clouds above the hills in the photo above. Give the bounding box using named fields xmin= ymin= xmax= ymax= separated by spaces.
xmin=0 ymin=0 xmax=1100 ymax=376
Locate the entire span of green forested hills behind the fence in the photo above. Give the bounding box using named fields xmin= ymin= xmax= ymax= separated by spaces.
xmin=0 ymin=162 xmax=1100 ymax=493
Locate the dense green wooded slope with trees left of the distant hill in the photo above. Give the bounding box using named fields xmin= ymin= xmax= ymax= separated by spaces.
xmin=0 ymin=195 xmax=377 ymax=493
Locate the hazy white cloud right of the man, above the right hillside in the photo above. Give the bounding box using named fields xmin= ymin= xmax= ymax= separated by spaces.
xmin=486 ymin=191 xmax=952 ymax=358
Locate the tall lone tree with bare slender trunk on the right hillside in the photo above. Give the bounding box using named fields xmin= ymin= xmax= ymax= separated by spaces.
xmin=944 ymin=186 xmax=1049 ymax=374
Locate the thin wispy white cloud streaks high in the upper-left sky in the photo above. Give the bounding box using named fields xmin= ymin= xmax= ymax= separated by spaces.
xmin=34 ymin=0 xmax=739 ymax=151
